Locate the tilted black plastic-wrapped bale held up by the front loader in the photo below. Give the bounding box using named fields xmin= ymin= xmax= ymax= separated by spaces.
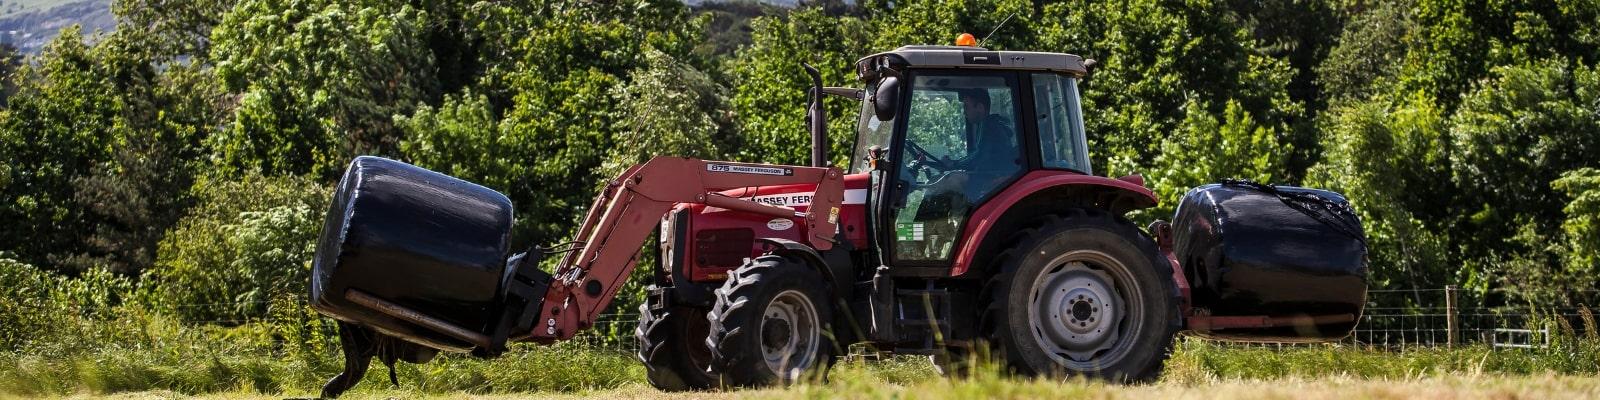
xmin=310 ymin=157 xmax=512 ymax=350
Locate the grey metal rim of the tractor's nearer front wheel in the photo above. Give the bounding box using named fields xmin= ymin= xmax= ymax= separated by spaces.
xmin=762 ymin=290 xmax=821 ymax=381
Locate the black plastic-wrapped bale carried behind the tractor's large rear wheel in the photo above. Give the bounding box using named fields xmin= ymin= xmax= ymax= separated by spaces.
xmin=1173 ymin=181 xmax=1368 ymax=341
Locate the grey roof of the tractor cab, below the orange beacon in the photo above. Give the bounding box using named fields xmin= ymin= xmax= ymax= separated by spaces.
xmin=856 ymin=45 xmax=1088 ymax=78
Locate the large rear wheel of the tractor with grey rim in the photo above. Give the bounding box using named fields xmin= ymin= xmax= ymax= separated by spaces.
xmin=979 ymin=210 xmax=1178 ymax=382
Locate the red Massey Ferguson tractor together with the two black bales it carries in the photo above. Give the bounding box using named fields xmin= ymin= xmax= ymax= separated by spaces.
xmin=312 ymin=38 xmax=1366 ymax=397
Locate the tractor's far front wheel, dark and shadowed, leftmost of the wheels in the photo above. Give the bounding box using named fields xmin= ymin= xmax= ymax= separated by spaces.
xmin=634 ymin=301 xmax=717 ymax=392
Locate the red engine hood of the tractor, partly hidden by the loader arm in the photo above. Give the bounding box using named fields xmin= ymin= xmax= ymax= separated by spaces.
xmin=666 ymin=173 xmax=869 ymax=282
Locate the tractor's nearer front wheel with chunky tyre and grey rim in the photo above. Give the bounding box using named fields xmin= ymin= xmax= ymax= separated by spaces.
xmin=706 ymin=254 xmax=834 ymax=387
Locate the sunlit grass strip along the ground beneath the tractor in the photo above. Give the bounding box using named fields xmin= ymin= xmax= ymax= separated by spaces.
xmin=0 ymin=339 xmax=1600 ymax=398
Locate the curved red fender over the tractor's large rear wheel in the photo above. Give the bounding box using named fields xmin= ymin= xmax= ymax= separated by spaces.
xmin=950 ymin=170 xmax=1176 ymax=277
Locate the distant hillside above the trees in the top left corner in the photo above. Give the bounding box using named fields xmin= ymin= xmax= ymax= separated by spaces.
xmin=0 ymin=0 xmax=117 ymax=54
